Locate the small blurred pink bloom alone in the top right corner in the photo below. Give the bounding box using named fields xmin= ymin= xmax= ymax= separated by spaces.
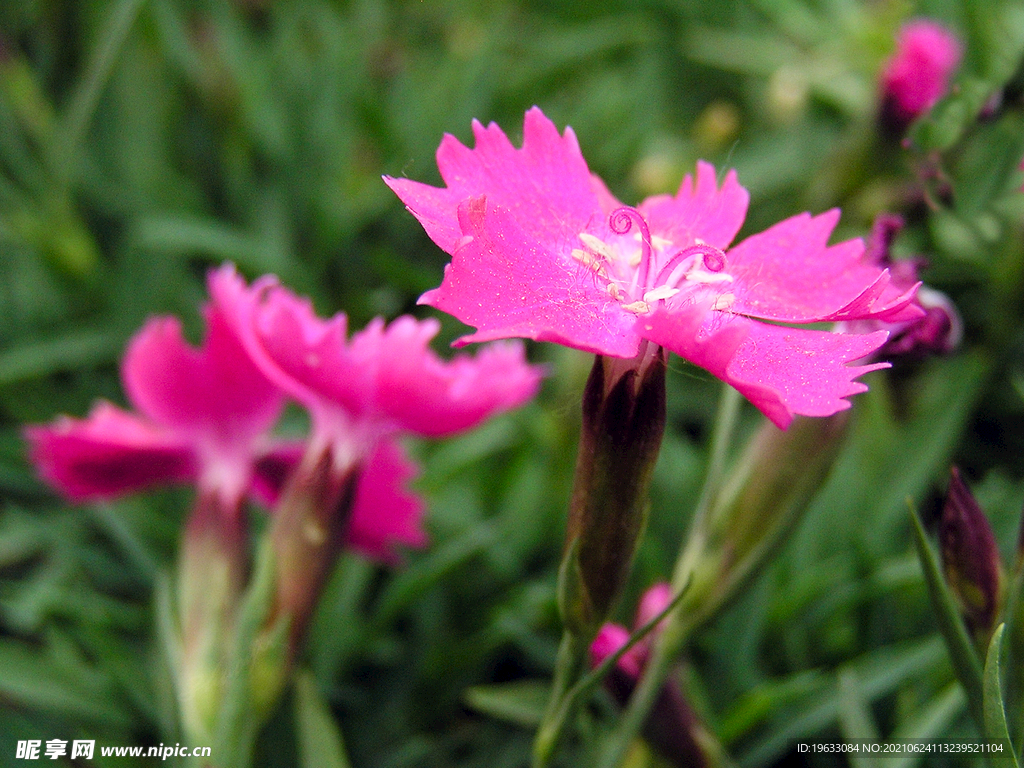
xmin=882 ymin=18 xmax=963 ymax=128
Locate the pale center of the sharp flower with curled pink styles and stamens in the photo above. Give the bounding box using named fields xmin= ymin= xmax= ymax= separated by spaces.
xmin=572 ymin=206 xmax=735 ymax=314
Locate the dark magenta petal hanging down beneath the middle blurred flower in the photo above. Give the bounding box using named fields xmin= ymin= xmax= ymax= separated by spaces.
xmin=345 ymin=440 xmax=427 ymax=563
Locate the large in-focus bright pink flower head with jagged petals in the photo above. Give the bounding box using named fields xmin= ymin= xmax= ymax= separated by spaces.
xmin=385 ymin=108 xmax=921 ymax=428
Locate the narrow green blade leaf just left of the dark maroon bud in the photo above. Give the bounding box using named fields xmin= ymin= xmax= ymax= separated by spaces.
xmin=910 ymin=507 xmax=985 ymax=730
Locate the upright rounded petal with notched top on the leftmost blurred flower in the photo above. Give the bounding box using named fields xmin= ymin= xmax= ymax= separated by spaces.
xmin=121 ymin=306 xmax=284 ymax=453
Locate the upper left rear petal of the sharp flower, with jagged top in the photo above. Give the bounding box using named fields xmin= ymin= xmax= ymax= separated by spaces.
xmin=384 ymin=106 xmax=602 ymax=254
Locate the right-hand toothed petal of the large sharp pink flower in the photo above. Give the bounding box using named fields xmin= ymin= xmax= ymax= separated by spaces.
xmin=725 ymin=210 xmax=921 ymax=323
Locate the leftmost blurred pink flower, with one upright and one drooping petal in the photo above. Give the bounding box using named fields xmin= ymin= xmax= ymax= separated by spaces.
xmin=25 ymin=307 xmax=284 ymax=510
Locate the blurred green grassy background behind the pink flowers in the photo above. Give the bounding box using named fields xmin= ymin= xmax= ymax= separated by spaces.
xmin=6 ymin=0 xmax=1024 ymax=768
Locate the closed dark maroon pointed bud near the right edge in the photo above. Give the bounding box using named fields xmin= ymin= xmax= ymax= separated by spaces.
xmin=939 ymin=467 xmax=1002 ymax=643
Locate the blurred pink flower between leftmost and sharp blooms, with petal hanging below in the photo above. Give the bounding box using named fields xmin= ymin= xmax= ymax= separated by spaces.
xmin=209 ymin=265 xmax=541 ymax=561
